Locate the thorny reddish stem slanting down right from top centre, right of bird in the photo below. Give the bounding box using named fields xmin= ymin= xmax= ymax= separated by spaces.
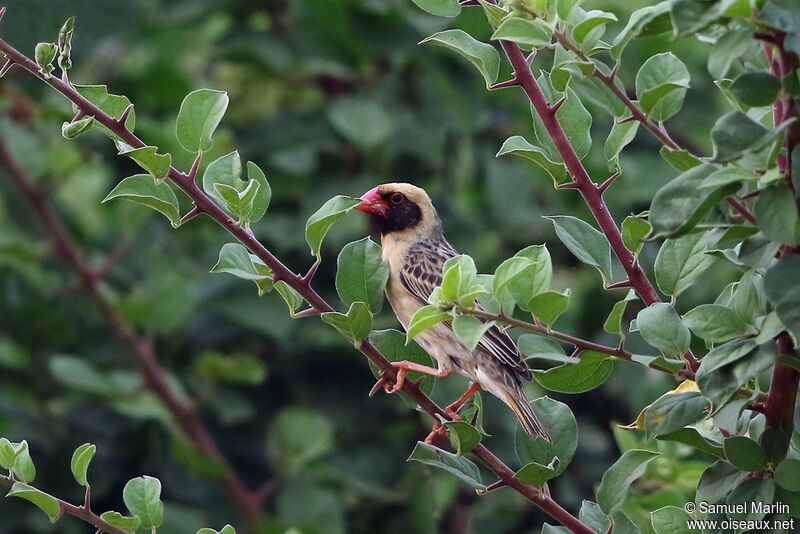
xmin=488 ymin=35 xmax=700 ymax=376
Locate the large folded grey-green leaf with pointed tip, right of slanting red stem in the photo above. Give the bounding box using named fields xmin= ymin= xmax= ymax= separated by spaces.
xmin=649 ymin=164 xmax=739 ymax=237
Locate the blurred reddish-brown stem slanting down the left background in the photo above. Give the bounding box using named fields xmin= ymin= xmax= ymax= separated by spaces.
xmin=0 ymin=138 xmax=262 ymax=521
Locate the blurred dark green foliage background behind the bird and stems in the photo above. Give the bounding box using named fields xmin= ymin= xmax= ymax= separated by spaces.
xmin=0 ymin=0 xmax=729 ymax=534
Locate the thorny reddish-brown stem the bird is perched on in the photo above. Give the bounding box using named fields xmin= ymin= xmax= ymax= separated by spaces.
xmin=0 ymin=28 xmax=593 ymax=534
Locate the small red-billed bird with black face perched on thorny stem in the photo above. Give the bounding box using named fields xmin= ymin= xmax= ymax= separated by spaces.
xmin=356 ymin=183 xmax=552 ymax=442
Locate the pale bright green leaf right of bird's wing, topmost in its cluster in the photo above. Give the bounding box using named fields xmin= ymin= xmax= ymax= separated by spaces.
xmin=492 ymin=245 xmax=553 ymax=314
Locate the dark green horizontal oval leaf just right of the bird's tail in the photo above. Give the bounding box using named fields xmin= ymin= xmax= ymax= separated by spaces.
xmin=533 ymin=351 xmax=614 ymax=393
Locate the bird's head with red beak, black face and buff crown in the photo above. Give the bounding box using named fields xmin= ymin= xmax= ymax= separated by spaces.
xmin=356 ymin=183 xmax=440 ymax=239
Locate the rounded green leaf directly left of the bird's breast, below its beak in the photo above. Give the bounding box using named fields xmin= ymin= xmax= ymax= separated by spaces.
xmin=336 ymin=237 xmax=389 ymax=313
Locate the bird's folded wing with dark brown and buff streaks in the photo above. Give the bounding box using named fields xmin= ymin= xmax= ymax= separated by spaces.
xmin=400 ymin=238 xmax=532 ymax=380
